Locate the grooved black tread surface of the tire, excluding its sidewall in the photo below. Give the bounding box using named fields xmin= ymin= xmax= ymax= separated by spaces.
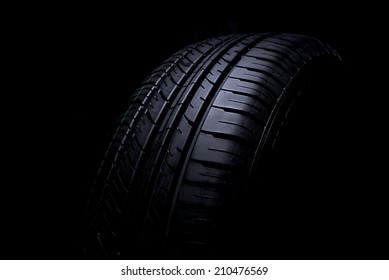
xmin=85 ymin=34 xmax=339 ymax=258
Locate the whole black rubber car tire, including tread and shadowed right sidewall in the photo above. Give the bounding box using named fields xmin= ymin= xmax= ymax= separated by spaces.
xmin=83 ymin=33 xmax=342 ymax=258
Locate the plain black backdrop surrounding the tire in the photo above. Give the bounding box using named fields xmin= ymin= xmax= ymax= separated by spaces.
xmin=0 ymin=6 xmax=389 ymax=259
